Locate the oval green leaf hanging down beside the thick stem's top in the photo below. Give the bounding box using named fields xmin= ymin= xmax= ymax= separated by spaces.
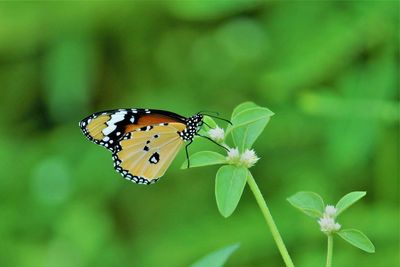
xmin=215 ymin=165 xmax=248 ymax=218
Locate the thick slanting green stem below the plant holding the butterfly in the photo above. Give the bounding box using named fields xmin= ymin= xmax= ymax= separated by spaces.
xmin=247 ymin=172 xmax=294 ymax=267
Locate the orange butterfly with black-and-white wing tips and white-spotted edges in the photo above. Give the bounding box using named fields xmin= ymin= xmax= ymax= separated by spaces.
xmin=79 ymin=108 xmax=204 ymax=184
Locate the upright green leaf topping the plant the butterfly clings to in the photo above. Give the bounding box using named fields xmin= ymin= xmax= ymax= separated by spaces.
xmin=227 ymin=102 xmax=274 ymax=151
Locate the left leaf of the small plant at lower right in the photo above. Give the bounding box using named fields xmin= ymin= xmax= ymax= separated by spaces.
xmin=287 ymin=192 xmax=325 ymax=218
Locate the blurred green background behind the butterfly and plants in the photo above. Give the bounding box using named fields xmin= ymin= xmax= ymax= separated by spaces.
xmin=0 ymin=1 xmax=400 ymax=267
